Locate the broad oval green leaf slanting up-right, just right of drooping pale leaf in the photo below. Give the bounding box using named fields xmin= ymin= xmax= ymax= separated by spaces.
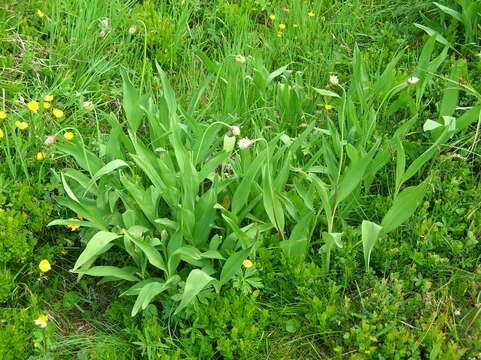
xmin=381 ymin=182 xmax=427 ymax=233
